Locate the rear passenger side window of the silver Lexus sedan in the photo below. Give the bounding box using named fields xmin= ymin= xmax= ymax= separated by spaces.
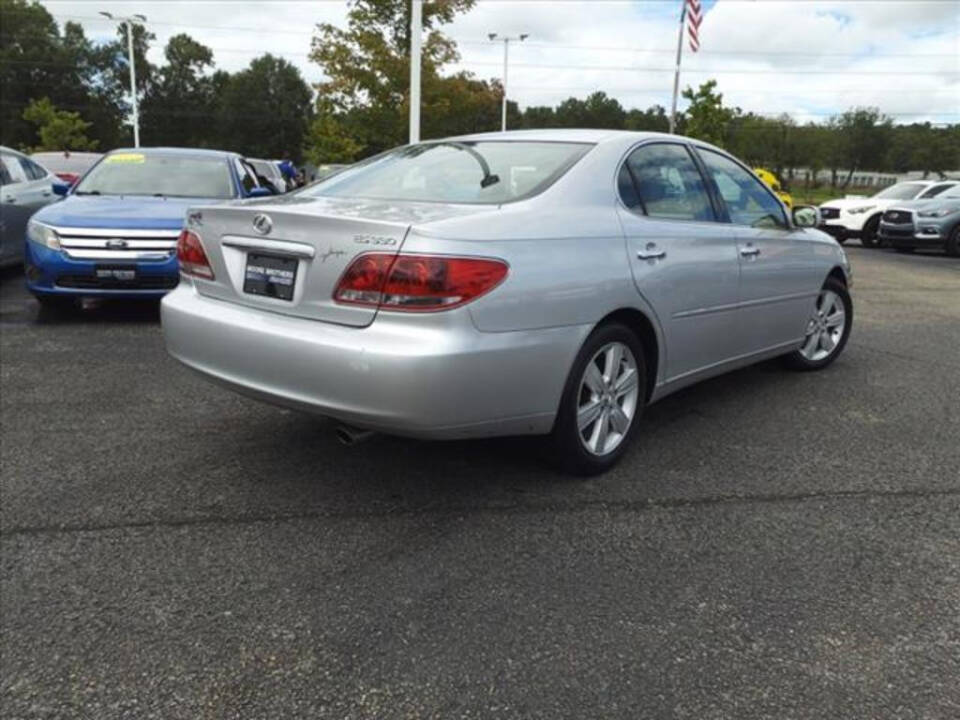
xmin=618 ymin=143 xmax=716 ymax=221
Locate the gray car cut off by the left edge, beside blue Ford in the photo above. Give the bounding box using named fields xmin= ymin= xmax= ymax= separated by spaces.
xmin=0 ymin=145 xmax=59 ymax=267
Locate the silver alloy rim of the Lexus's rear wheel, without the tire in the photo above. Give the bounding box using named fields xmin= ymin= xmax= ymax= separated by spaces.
xmin=577 ymin=342 xmax=640 ymax=455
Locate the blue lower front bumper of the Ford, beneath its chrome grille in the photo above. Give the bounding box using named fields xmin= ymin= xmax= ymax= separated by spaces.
xmin=24 ymin=241 xmax=180 ymax=298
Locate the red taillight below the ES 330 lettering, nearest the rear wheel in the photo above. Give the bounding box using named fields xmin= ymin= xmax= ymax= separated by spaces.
xmin=333 ymin=253 xmax=507 ymax=312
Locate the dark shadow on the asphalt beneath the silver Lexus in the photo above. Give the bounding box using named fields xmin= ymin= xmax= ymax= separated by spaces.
xmin=208 ymin=361 xmax=798 ymax=515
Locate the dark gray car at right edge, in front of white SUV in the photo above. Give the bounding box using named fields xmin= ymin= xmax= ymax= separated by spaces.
xmin=879 ymin=184 xmax=960 ymax=257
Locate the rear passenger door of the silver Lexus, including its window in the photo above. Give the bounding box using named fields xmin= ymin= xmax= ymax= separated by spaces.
xmin=617 ymin=141 xmax=740 ymax=381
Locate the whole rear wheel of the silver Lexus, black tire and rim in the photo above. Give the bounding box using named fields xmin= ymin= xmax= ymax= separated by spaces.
xmin=546 ymin=322 xmax=647 ymax=476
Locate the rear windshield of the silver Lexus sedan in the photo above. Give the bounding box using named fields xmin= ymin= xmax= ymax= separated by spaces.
xmin=304 ymin=141 xmax=593 ymax=205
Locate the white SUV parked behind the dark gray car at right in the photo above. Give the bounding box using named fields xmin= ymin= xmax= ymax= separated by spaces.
xmin=820 ymin=180 xmax=960 ymax=247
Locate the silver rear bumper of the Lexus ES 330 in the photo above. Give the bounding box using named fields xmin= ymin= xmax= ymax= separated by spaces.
xmin=161 ymin=281 xmax=590 ymax=439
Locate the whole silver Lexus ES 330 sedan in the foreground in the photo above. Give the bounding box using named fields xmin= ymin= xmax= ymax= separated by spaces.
xmin=162 ymin=130 xmax=853 ymax=473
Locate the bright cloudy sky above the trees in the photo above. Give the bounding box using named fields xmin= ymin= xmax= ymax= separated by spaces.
xmin=35 ymin=0 xmax=960 ymax=124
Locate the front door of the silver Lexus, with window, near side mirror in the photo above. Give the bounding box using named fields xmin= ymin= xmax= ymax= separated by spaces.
xmin=696 ymin=147 xmax=823 ymax=353
